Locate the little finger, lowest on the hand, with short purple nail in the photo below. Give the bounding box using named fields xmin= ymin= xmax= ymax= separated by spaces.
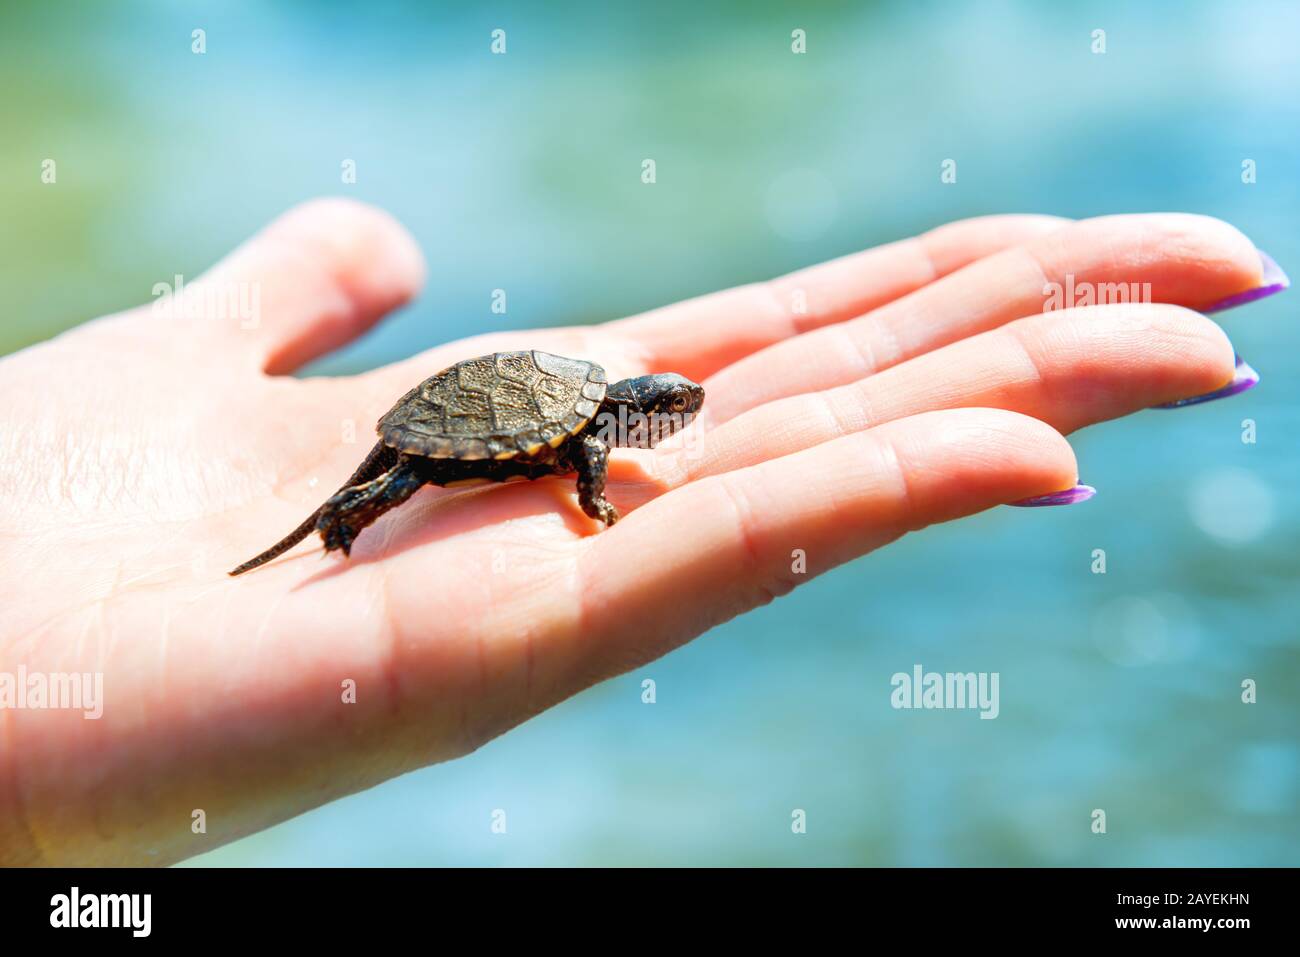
xmin=574 ymin=408 xmax=1078 ymax=681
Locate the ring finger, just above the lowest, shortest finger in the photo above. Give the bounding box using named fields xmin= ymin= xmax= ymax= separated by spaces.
xmin=653 ymin=304 xmax=1235 ymax=488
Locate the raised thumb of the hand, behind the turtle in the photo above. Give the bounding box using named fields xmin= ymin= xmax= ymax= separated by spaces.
xmin=185 ymin=199 xmax=425 ymax=374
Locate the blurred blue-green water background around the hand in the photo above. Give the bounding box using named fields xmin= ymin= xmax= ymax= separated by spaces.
xmin=0 ymin=1 xmax=1300 ymax=865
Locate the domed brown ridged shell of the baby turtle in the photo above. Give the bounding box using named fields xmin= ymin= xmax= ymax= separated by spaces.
xmin=376 ymin=350 xmax=607 ymax=459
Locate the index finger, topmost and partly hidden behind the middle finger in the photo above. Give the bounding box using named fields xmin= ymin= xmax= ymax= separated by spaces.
xmin=603 ymin=216 xmax=1069 ymax=381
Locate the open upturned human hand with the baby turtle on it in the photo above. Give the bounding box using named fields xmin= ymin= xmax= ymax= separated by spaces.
xmin=0 ymin=200 xmax=1264 ymax=863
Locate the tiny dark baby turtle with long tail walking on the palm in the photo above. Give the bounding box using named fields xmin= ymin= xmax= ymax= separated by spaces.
xmin=230 ymin=350 xmax=705 ymax=575
